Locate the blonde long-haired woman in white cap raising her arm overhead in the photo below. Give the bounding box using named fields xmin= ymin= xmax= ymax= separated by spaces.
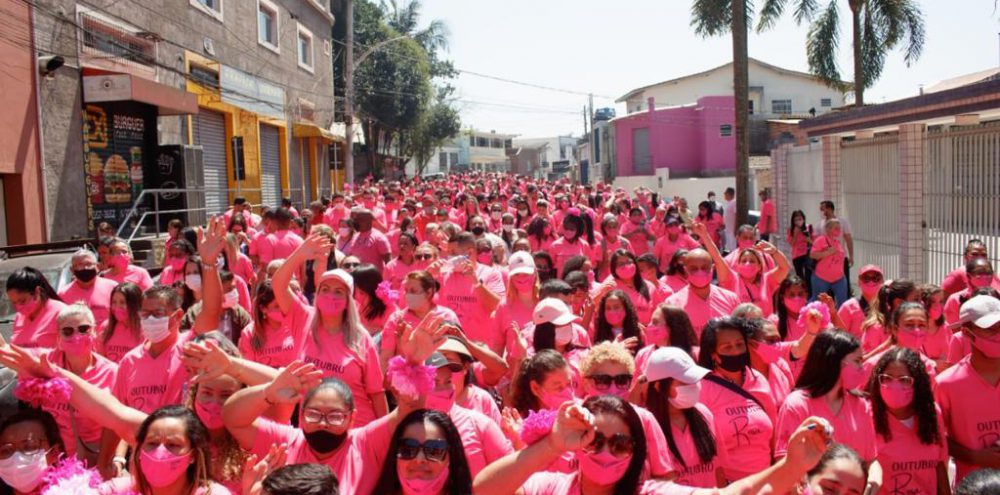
xmin=272 ymin=235 xmax=389 ymax=426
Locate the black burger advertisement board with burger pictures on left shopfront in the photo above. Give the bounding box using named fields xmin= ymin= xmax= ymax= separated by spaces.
xmin=83 ymin=103 xmax=156 ymax=231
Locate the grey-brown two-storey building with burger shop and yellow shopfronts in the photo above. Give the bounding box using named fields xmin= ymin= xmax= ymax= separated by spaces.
xmin=7 ymin=0 xmax=340 ymax=240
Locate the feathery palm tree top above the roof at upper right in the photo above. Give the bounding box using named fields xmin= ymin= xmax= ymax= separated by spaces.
xmin=757 ymin=0 xmax=925 ymax=106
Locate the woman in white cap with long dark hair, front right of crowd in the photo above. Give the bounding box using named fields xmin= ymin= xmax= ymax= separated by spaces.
xmin=644 ymin=347 xmax=727 ymax=488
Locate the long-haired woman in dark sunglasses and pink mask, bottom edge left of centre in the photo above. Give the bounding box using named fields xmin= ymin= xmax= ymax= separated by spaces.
xmin=372 ymin=409 xmax=472 ymax=495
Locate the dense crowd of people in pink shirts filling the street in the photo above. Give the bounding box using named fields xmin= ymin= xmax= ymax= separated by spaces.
xmin=0 ymin=173 xmax=1000 ymax=495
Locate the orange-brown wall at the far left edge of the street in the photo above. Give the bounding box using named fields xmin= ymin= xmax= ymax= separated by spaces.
xmin=0 ymin=0 xmax=46 ymax=245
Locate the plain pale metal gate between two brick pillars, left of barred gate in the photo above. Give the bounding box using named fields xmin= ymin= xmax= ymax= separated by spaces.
xmin=836 ymin=137 xmax=901 ymax=282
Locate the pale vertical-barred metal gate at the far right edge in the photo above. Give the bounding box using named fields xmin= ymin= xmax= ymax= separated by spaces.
xmin=924 ymin=122 xmax=1000 ymax=283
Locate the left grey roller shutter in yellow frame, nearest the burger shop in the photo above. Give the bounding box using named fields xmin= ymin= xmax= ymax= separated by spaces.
xmin=192 ymin=108 xmax=229 ymax=214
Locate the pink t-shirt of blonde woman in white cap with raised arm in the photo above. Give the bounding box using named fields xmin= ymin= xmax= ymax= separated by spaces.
xmin=285 ymin=302 xmax=385 ymax=426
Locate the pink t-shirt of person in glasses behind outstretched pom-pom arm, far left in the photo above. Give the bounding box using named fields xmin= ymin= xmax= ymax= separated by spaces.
xmin=46 ymin=351 xmax=118 ymax=457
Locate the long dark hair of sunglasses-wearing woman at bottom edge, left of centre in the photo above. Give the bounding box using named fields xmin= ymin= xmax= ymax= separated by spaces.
xmin=372 ymin=409 xmax=472 ymax=495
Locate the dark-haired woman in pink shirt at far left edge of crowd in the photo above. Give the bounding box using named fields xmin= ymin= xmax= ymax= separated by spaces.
xmin=6 ymin=266 xmax=66 ymax=349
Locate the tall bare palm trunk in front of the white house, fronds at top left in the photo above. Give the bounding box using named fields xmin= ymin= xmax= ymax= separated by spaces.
xmin=691 ymin=0 xmax=750 ymax=228
